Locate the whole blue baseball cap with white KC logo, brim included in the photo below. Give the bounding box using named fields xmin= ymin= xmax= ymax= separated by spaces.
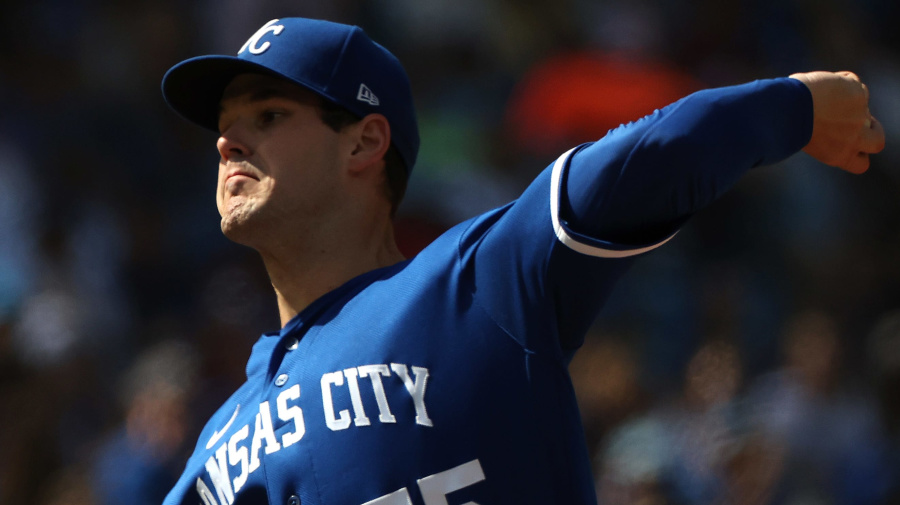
xmin=162 ymin=18 xmax=419 ymax=174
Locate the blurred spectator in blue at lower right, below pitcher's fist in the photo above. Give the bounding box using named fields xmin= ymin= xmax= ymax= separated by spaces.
xmin=750 ymin=311 xmax=889 ymax=505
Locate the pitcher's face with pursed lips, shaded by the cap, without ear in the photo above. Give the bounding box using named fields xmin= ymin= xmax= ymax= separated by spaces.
xmin=216 ymin=74 xmax=341 ymax=246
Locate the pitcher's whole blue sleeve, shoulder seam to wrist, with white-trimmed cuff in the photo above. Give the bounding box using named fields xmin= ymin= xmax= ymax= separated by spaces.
xmin=460 ymin=78 xmax=812 ymax=359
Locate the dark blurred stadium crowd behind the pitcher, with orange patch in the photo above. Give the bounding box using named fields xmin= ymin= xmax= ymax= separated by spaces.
xmin=0 ymin=0 xmax=900 ymax=505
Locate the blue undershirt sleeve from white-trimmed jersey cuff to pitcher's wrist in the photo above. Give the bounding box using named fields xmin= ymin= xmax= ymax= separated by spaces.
xmin=562 ymin=78 xmax=812 ymax=244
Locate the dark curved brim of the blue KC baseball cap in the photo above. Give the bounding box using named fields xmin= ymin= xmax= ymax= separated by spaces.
xmin=162 ymin=55 xmax=287 ymax=131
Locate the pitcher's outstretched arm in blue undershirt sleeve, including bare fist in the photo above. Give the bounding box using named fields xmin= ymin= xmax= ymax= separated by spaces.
xmin=560 ymin=72 xmax=884 ymax=245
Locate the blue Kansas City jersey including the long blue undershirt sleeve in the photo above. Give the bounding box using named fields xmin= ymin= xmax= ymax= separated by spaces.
xmin=165 ymin=79 xmax=812 ymax=505
